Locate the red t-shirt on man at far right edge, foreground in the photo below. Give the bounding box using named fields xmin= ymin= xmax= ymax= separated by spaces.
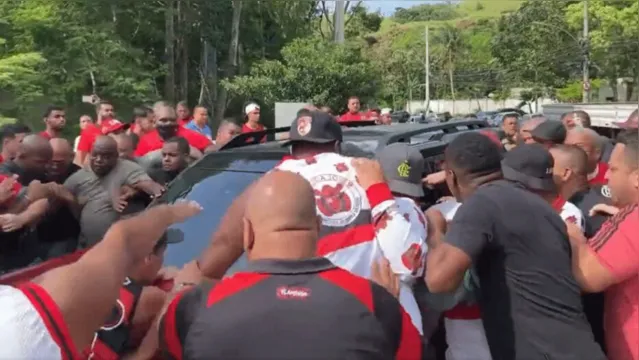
xmin=588 ymin=204 xmax=639 ymax=360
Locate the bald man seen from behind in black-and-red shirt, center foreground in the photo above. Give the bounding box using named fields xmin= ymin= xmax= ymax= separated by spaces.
xmin=160 ymin=171 xmax=421 ymax=360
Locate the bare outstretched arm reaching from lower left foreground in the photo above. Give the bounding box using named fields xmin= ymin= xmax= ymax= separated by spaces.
xmin=30 ymin=202 xmax=201 ymax=349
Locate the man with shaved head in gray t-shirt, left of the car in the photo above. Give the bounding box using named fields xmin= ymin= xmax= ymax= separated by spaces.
xmin=64 ymin=135 xmax=162 ymax=247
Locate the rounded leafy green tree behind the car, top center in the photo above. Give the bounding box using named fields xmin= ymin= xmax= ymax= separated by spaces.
xmin=224 ymin=38 xmax=378 ymax=110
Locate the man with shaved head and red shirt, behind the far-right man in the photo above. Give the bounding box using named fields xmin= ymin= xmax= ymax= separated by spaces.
xmin=564 ymin=127 xmax=608 ymax=185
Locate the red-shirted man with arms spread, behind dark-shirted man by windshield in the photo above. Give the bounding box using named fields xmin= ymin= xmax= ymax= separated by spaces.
xmin=134 ymin=101 xmax=213 ymax=157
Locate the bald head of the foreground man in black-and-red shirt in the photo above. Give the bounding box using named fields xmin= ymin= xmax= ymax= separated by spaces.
xmin=244 ymin=171 xmax=319 ymax=259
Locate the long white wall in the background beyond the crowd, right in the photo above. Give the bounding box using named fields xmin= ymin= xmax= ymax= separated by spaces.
xmin=406 ymin=98 xmax=555 ymax=114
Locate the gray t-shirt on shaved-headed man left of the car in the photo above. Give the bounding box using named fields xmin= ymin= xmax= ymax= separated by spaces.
xmin=64 ymin=159 xmax=151 ymax=246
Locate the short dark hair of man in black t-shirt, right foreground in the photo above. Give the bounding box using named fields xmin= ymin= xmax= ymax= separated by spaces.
xmin=444 ymin=132 xmax=502 ymax=178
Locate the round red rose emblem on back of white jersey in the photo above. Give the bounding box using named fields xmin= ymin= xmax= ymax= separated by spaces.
xmin=309 ymin=174 xmax=362 ymax=227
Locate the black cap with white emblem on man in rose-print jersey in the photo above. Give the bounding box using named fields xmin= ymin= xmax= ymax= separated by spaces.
xmin=284 ymin=111 xmax=342 ymax=146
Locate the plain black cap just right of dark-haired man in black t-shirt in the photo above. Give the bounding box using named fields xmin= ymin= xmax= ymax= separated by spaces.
xmin=501 ymin=144 xmax=556 ymax=191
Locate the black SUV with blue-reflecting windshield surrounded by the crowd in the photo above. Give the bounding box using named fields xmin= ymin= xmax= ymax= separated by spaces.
xmin=158 ymin=120 xmax=489 ymax=272
